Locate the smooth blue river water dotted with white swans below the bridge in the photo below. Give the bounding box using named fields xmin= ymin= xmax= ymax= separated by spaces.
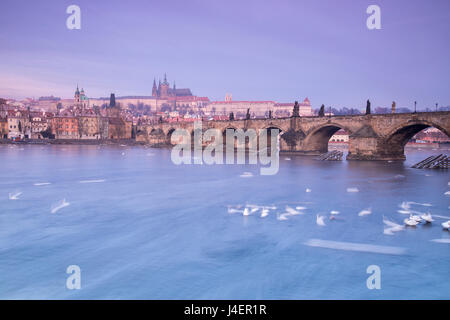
xmin=0 ymin=145 xmax=450 ymax=299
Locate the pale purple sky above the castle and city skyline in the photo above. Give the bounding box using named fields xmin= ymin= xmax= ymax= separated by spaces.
xmin=0 ymin=0 xmax=450 ymax=109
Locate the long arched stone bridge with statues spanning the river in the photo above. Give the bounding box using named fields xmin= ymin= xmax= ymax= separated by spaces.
xmin=137 ymin=111 xmax=450 ymax=160
